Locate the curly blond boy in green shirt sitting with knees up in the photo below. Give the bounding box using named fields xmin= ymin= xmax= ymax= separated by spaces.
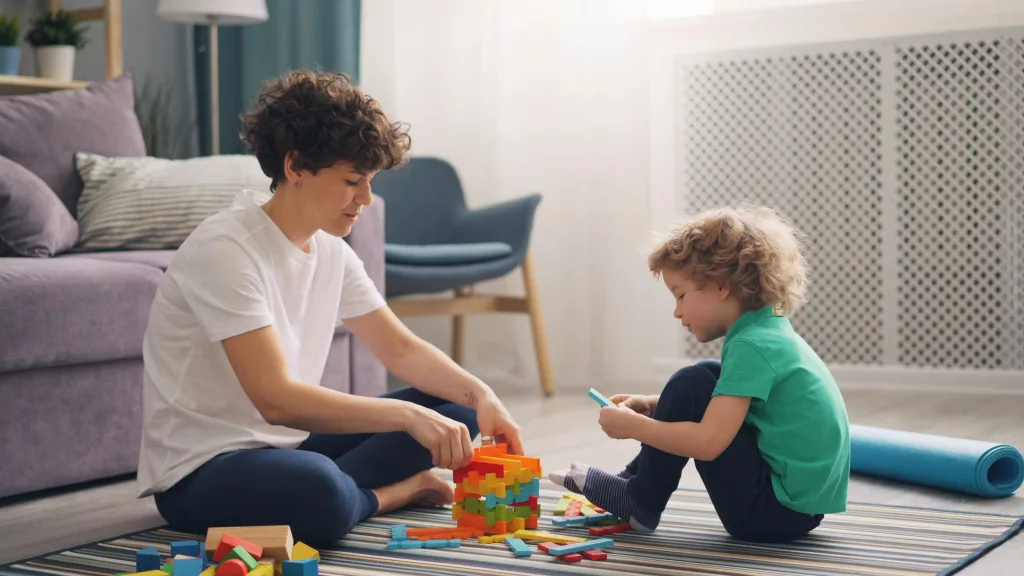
xmin=550 ymin=203 xmax=850 ymax=542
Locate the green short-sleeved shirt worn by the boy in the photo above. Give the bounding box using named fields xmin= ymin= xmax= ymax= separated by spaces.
xmin=713 ymin=306 xmax=850 ymax=515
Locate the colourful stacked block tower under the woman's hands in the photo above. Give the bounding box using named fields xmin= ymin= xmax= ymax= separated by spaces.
xmin=452 ymin=444 xmax=541 ymax=534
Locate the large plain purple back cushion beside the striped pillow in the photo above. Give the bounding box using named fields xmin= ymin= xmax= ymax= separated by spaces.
xmin=0 ymin=74 xmax=145 ymax=216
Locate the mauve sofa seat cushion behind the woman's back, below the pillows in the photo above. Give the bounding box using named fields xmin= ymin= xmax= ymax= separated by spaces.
xmin=0 ymin=258 xmax=163 ymax=372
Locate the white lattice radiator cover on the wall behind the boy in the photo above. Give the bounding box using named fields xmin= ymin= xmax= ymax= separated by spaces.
xmin=675 ymin=30 xmax=1024 ymax=377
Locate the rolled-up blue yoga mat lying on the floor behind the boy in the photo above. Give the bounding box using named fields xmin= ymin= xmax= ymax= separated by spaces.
xmin=850 ymin=424 xmax=1024 ymax=498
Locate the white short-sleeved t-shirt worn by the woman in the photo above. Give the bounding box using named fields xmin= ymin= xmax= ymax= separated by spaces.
xmin=138 ymin=191 xmax=385 ymax=496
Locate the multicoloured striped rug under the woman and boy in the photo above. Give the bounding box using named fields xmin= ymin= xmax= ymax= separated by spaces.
xmin=0 ymin=481 xmax=1024 ymax=576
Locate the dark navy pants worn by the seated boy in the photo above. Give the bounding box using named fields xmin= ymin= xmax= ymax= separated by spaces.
xmin=627 ymin=361 xmax=822 ymax=542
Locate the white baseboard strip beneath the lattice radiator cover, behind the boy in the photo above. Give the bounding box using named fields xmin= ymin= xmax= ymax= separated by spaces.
xmin=652 ymin=358 xmax=1024 ymax=395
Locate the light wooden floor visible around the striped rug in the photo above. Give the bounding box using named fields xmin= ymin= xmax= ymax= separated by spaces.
xmin=0 ymin=383 xmax=1024 ymax=576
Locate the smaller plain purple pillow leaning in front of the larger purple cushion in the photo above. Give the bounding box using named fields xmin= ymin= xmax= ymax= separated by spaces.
xmin=0 ymin=156 xmax=78 ymax=258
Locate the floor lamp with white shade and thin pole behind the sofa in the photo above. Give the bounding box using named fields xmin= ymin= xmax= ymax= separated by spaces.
xmin=157 ymin=0 xmax=267 ymax=155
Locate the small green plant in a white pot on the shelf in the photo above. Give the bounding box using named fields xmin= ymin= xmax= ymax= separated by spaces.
xmin=26 ymin=10 xmax=89 ymax=81
